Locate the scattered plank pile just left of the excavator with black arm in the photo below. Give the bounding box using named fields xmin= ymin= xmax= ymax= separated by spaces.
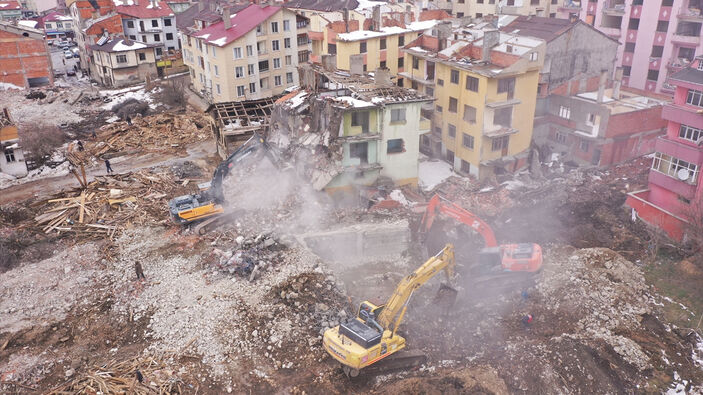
xmin=34 ymin=170 xmax=183 ymax=238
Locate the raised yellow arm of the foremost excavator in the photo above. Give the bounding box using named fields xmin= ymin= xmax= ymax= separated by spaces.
xmin=378 ymin=244 xmax=454 ymax=334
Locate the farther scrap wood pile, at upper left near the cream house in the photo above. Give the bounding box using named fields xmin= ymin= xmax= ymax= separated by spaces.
xmin=86 ymin=112 xmax=210 ymax=157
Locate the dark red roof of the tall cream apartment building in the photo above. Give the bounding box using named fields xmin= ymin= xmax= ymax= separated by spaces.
xmin=193 ymin=4 xmax=282 ymax=47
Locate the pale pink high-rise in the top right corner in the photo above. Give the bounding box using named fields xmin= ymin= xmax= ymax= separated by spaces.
xmin=581 ymin=0 xmax=703 ymax=94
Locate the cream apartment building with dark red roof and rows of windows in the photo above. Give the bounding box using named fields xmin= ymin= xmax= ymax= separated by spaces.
xmin=182 ymin=4 xmax=310 ymax=103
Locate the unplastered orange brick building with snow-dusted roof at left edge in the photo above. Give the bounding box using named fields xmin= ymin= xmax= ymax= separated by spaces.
xmin=0 ymin=21 xmax=54 ymax=89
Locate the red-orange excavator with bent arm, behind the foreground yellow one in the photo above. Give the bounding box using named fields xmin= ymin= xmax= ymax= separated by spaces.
xmin=420 ymin=195 xmax=542 ymax=272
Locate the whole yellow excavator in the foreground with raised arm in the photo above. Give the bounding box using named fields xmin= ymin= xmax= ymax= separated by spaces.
xmin=322 ymin=244 xmax=457 ymax=377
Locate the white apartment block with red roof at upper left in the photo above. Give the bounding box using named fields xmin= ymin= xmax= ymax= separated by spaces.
xmin=115 ymin=0 xmax=180 ymax=54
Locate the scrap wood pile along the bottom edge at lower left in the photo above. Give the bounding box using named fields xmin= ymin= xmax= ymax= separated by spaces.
xmin=49 ymin=355 xmax=193 ymax=395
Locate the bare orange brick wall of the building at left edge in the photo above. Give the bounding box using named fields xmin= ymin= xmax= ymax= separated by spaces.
xmin=0 ymin=30 xmax=54 ymax=88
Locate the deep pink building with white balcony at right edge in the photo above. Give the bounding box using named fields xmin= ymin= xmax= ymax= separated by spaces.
xmin=627 ymin=57 xmax=703 ymax=241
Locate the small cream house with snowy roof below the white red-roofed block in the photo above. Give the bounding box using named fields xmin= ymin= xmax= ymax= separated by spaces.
xmin=90 ymin=37 xmax=162 ymax=87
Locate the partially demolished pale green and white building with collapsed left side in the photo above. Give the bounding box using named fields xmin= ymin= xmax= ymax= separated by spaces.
xmin=268 ymin=60 xmax=433 ymax=194
